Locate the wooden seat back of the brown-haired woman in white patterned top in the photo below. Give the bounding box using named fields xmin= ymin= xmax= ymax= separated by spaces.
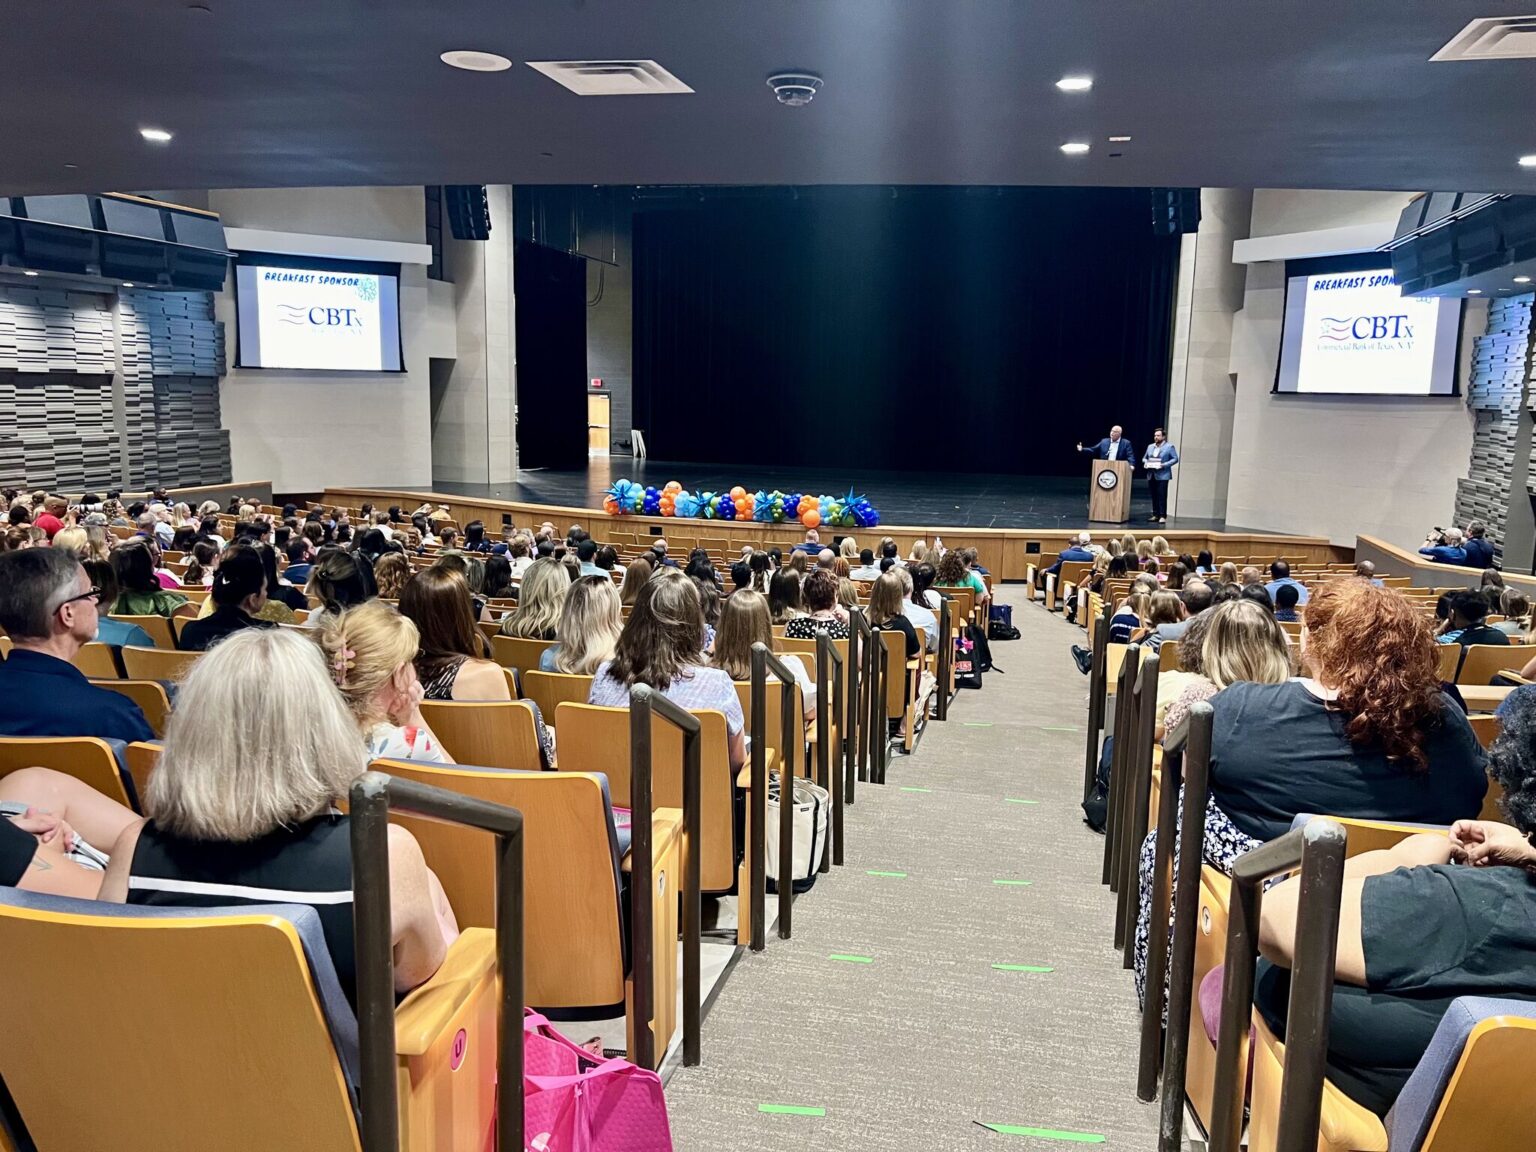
xmin=556 ymin=703 xmax=736 ymax=892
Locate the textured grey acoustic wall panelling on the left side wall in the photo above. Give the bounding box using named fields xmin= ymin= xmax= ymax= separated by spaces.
xmin=0 ymin=287 xmax=232 ymax=492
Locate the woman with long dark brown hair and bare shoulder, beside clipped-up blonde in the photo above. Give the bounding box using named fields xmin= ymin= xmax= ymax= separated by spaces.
xmin=399 ymin=565 xmax=511 ymax=700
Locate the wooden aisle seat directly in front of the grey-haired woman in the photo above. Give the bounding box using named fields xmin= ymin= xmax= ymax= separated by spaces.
xmin=373 ymin=760 xmax=682 ymax=1060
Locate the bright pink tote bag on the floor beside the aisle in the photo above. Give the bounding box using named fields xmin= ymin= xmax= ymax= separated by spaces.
xmin=522 ymin=1011 xmax=673 ymax=1152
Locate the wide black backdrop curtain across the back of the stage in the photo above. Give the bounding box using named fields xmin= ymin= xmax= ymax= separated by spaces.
xmin=634 ymin=187 xmax=1178 ymax=482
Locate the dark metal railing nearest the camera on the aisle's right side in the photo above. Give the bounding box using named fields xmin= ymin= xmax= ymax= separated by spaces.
xmin=1210 ymin=819 xmax=1346 ymax=1152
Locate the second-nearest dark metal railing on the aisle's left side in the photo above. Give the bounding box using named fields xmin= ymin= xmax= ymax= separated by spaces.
xmin=630 ymin=684 xmax=703 ymax=1068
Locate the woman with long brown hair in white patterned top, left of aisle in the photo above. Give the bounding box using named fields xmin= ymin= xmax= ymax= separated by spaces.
xmin=587 ymin=573 xmax=743 ymax=771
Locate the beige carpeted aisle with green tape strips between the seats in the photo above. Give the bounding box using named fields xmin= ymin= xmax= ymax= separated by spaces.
xmin=667 ymin=588 xmax=1157 ymax=1152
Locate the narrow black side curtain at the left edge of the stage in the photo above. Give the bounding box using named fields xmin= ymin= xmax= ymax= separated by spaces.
xmin=511 ymin=240 xmax=587 ymax=470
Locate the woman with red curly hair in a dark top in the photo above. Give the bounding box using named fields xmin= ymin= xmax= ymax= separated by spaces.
xmin=1210 ymin=579 xmax=1488 ymax=840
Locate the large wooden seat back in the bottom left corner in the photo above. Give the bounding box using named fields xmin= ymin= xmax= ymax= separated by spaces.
xmin=0 ymin=889 xmax=361 ymax=1152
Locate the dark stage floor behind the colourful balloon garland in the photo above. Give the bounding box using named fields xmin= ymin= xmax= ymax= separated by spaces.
xmin=420 ymin=456 xmax=1247 ymax=535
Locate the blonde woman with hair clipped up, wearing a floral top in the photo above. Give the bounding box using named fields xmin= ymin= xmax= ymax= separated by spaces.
xmin=313 ymin=601 xmax=453 ymax=763
